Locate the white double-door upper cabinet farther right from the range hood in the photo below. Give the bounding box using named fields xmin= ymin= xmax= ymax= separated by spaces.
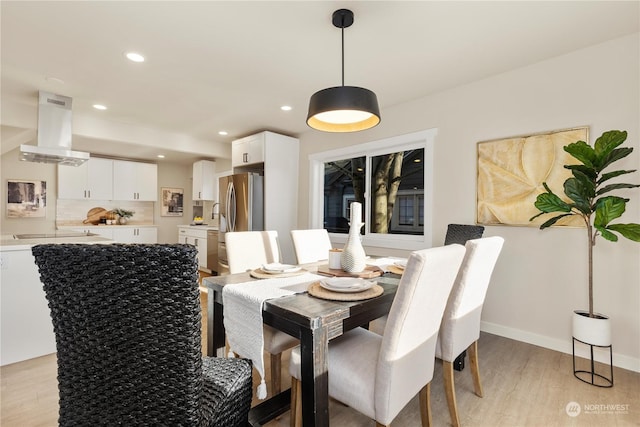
xmin=113 ymin=160 xmax=158 ymax=201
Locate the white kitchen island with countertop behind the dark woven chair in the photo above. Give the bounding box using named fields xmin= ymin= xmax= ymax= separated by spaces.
xmin=0 ymin=233 xmax=113 ymax=365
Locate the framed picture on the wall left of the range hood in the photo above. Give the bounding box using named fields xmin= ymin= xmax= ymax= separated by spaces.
xmin=7 ymin=179 xmax=47 ymax=218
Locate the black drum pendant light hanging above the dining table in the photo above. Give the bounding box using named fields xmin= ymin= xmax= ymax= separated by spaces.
xmin=307 ymin=9 xmax=380 ymax=132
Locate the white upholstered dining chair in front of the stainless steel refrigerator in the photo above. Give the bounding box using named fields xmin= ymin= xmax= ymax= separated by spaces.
xmin=225 ymin=230 xmax=299 ymax=396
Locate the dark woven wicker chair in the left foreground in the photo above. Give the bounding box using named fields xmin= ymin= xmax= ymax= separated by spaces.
xmin=33 ymin=244 xmax=252 ymax=427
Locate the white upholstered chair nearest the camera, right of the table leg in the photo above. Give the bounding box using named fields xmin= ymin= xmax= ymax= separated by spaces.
xmin=289 ymin=244 xmax=465 ymax=426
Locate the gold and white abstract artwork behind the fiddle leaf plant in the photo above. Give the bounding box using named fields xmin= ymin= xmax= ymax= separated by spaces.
xmin=477 ymin=127 xmax=589 ymax=227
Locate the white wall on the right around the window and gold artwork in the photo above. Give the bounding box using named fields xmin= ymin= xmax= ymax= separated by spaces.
xmin=298 ymin=33 xmax=640 ymax=371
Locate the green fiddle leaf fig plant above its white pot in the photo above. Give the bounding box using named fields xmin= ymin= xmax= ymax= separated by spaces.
xmin=529 ymin=130 xmax=640 ymax=317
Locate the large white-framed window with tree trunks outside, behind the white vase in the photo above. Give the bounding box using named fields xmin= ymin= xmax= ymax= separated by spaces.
xmin=310 ymin=130 xmax=436 ymax=250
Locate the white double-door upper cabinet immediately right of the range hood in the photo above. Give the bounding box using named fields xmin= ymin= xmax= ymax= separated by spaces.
xmin=58 ymin=157 xmax=113 ymax=200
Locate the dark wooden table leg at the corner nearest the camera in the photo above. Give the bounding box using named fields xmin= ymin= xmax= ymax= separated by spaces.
xmin=300 ymin=328 xmax=329 ymax=427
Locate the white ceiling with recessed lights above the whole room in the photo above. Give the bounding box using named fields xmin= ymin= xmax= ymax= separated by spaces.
xmin=0 ymin=0 xmax=640 ymax=162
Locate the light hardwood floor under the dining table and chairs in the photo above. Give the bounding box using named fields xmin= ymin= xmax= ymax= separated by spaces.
xmin=0 ymin=292 xmax=640 ymax=427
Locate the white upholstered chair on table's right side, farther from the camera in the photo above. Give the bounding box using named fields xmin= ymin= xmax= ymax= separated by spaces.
xmin=436 ymin=236 xmax=504 ymax=427
